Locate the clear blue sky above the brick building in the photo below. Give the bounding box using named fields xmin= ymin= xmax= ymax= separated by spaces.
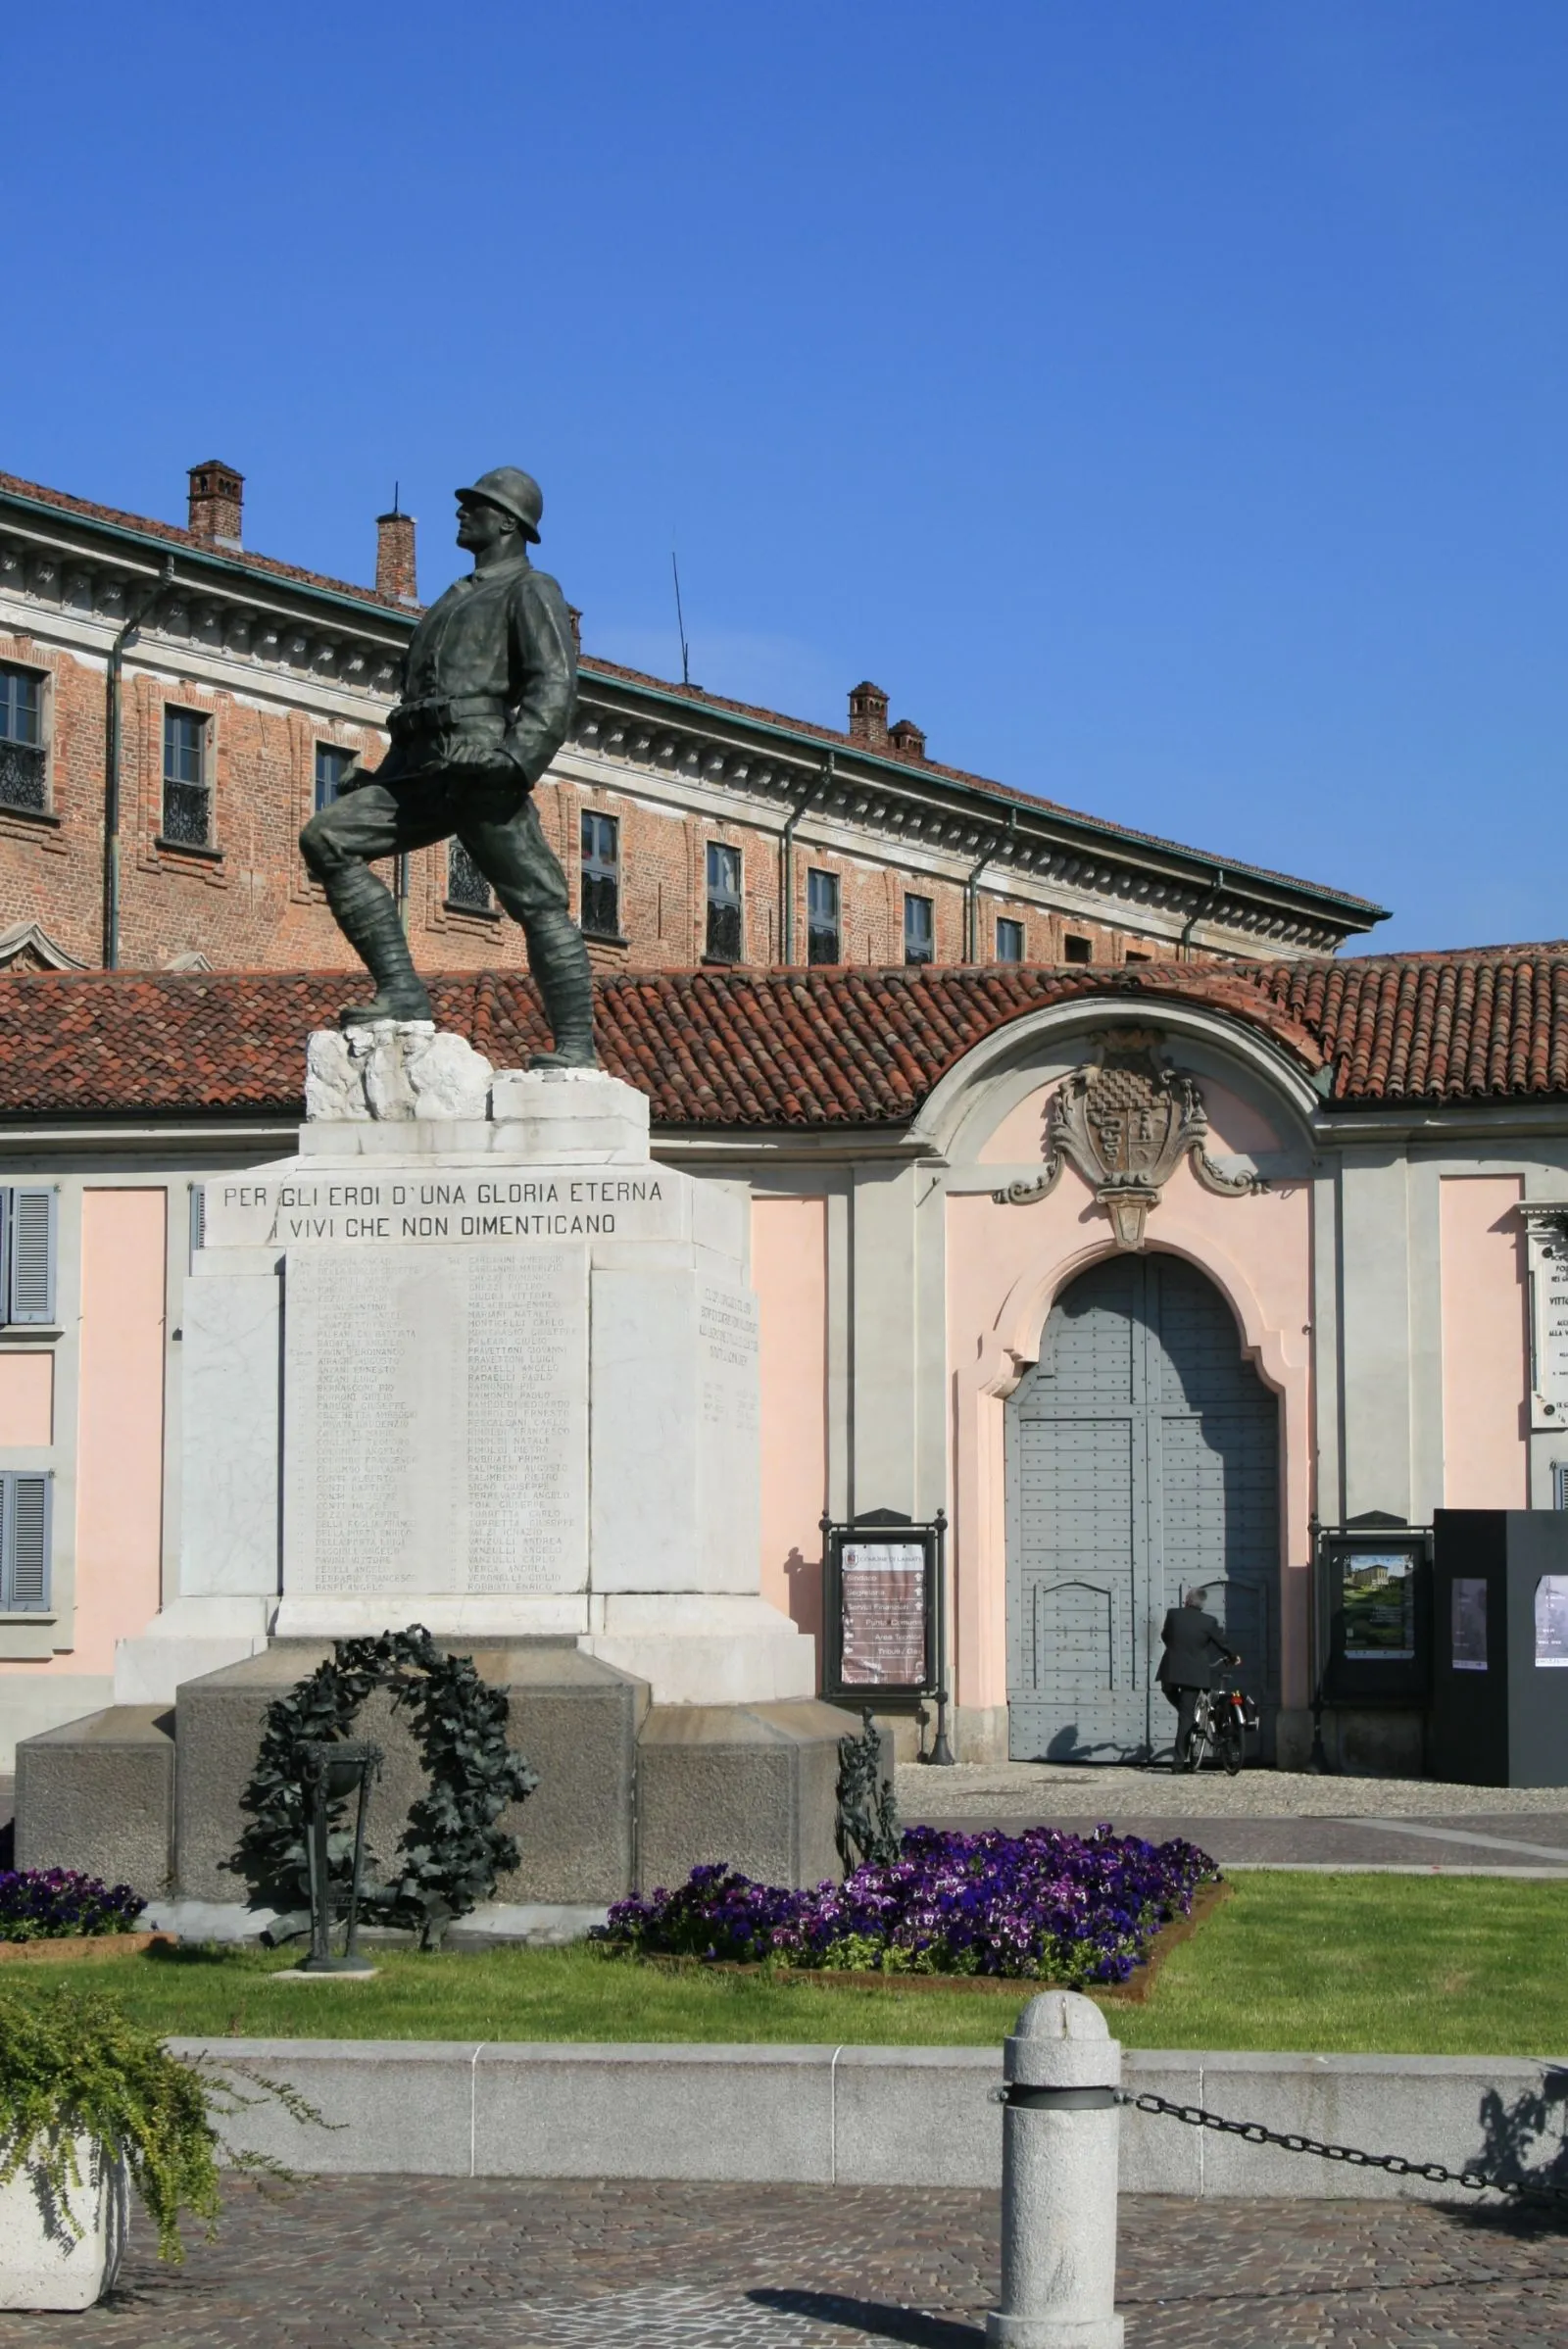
xmin=0 ymin=0 xmax=1568 ymax=947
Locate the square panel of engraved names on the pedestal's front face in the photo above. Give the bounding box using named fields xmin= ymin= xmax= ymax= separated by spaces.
xmin=284 ymin=1245 xmax=587 ymax=1597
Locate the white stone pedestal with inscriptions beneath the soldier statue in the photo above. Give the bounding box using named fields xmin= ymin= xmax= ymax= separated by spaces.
xmin=118 ymin=1024 xmax=814 ymax=1703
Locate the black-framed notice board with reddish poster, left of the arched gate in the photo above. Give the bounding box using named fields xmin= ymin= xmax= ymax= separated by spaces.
xmin=821 ymin=1522 xmax=941 ymax=1696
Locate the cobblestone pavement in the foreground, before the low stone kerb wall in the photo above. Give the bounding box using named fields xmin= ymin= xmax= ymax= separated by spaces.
xmin=0 ymin=2178 xmax=1568 ymax=2349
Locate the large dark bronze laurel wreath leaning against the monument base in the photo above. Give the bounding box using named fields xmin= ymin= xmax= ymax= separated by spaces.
xmin=227 ymin=1623 xmax=540 ymax=1950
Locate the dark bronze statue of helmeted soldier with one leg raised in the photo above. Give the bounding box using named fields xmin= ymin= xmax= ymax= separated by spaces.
xmin=301 ymin=465 xmax=596 ymax=1069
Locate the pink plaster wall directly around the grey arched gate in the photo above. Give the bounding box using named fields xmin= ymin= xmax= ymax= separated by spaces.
xmin=949 ymin=1164 xmax=1312 ymax=1705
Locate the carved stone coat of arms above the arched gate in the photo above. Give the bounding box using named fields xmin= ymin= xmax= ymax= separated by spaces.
xmin=991 ymin=1029 xmax=1267 ymax=1248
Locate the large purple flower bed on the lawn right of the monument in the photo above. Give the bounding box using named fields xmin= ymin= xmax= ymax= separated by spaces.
xmin=596 ymin=1828 xmax=1218 ymax=1987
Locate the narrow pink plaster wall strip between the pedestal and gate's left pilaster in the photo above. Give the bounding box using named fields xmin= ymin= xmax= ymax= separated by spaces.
xmin=751 ymin=1198 xmax=829 ymax=1661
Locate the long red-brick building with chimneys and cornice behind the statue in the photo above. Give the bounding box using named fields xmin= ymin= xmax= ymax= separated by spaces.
xmin=0 ymin=461 xmax=1383 ymax=970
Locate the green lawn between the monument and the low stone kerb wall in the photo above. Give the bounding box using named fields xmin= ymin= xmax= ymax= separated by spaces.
xmin=0 ymin=1875 xmax=1568 ymax=2055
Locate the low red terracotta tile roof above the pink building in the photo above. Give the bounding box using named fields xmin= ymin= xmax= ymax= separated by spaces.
xmin=0 ymin=945 xmax=1568 ymax=1128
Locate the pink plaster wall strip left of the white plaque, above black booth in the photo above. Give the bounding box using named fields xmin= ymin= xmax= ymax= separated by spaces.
xmin=1439 ymin=1175 xmax=1531 ymax=1508
